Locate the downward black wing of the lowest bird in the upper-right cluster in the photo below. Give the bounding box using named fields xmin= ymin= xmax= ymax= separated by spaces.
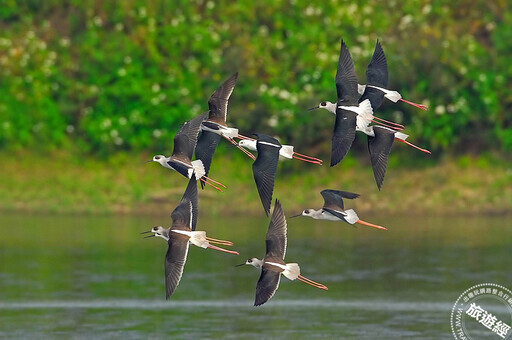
xmin=368 ymin=126 xmax=395 ymax=190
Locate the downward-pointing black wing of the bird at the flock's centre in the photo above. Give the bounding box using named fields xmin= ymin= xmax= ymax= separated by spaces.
xmin=252 ymin=135 xmax=281 ymax=216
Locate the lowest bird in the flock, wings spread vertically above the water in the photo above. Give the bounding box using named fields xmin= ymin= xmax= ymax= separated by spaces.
xmin=238 ymin=199 xmax=328 ymax=306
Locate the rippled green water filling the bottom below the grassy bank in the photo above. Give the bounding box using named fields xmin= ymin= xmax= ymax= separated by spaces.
xmin=0 ymin=212 xmax=512 ymax=339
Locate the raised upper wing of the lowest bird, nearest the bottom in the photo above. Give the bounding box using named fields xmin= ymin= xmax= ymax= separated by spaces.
xmin=265 ymin=199 xmax=286 ymax=260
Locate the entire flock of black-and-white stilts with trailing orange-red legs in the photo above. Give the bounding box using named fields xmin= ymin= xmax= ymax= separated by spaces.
xmin=139 ymin=40 xmax=430 ymax=306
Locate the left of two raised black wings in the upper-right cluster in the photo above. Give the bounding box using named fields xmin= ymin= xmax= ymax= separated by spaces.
xmin=336 ymin=40 xmax=359 ymax=106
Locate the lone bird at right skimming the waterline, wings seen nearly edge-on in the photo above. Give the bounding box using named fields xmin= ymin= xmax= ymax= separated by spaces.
xmin=291 ymin=189 xmax=387 ymax=230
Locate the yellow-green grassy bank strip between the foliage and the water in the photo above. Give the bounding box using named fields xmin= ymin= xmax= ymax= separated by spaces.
xmin=0 ymin=151 xmax=512 ymax=215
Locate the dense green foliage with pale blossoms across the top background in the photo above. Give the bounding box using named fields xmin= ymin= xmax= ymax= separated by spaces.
xmin=0 ymin=0 xmax=512 ymax=154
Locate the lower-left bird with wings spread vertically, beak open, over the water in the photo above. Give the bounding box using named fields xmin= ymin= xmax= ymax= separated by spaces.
xmin=142 ymin=179 xmax=238 ymax=300
